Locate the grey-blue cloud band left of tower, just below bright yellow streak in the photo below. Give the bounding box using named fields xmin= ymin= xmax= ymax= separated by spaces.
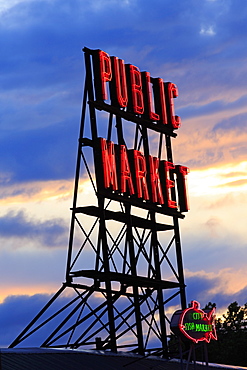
xmin=0 ymin=212 xmax=68 ymax=247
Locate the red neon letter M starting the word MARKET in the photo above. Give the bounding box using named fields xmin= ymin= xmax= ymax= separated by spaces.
xmin=100 ymin=138 xmax=118 ymax=190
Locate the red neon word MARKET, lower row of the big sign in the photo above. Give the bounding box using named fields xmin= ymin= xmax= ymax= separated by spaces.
xmin=98 ymin=138 xmax=189 ymax=212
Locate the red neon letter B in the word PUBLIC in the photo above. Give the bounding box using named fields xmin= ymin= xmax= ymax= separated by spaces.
xmin=126 ymin=64 xmax=144 ymax=114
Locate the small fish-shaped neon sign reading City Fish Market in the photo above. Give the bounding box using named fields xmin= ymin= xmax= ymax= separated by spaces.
xmin=170 ymin=301 xmax=217 ymax=343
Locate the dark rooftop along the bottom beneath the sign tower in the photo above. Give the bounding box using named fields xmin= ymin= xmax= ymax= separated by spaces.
xmin=0 ymin=348 xmax=247 ymax=370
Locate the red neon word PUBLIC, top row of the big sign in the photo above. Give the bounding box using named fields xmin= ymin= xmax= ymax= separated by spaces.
xmin=92 ymin=50 xmax=181 ymax=129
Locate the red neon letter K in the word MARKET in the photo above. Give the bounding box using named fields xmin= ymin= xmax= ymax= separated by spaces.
xmin=149 ymin=155 xmax=164 ymax=204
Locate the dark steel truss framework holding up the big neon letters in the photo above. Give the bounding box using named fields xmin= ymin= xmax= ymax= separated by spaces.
xmin=10 ymin=48 xmax=186 ymax=357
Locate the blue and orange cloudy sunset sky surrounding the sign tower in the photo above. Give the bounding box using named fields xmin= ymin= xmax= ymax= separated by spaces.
xmin=0 ymin=0 xmax=247 ymax=346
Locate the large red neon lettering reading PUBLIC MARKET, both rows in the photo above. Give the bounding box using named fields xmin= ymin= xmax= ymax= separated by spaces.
xmin=91 ymin=50 xmax=189 ymax=212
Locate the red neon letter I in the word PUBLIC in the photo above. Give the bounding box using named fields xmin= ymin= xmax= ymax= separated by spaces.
xmin=153 ymin=78 xmax=167 ymax=125
